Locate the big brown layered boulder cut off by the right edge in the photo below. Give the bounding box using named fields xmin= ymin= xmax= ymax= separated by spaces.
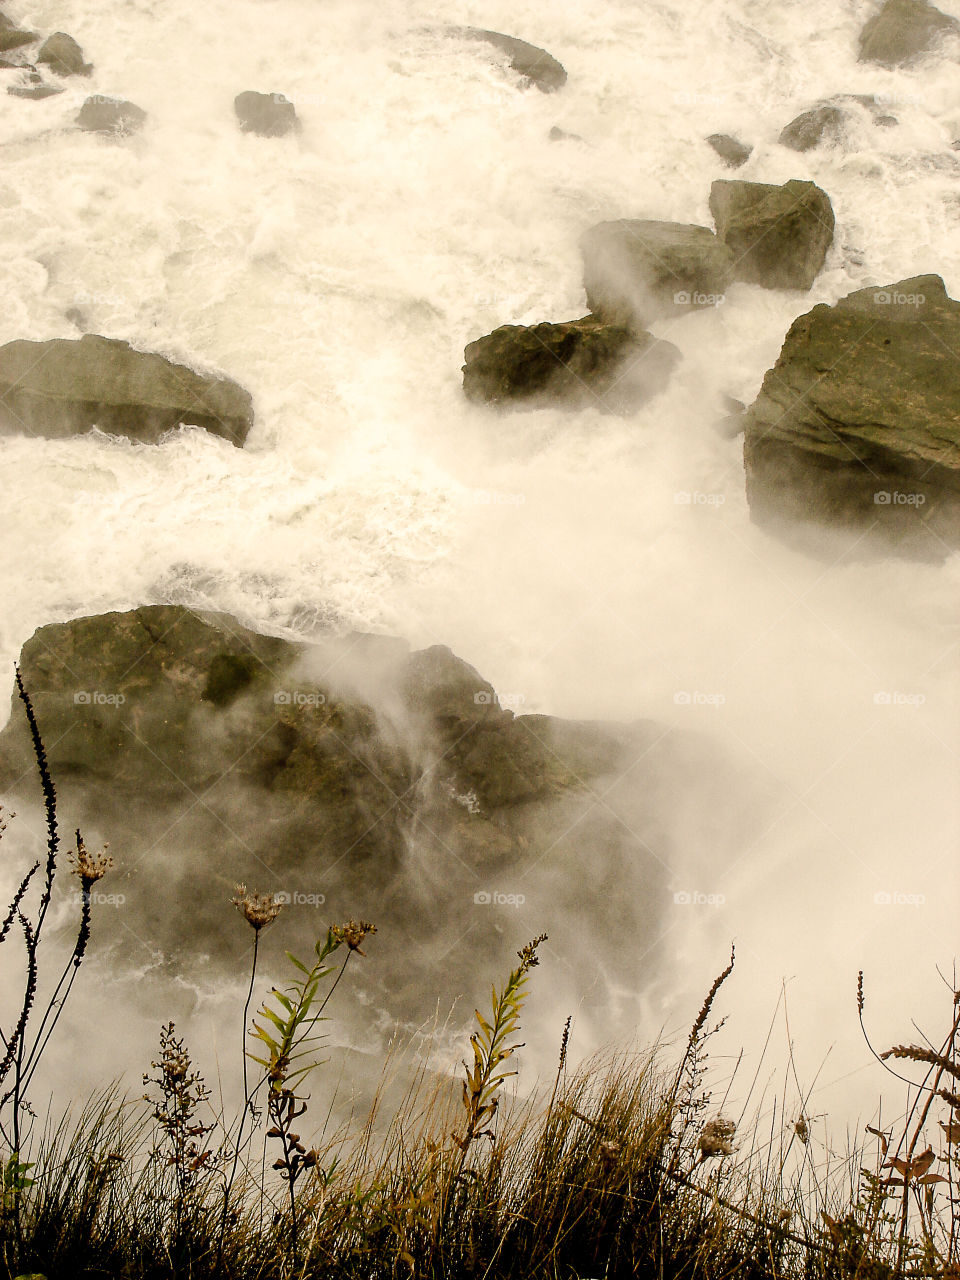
xmin=744 ymin=275 xmax=960 ymax=556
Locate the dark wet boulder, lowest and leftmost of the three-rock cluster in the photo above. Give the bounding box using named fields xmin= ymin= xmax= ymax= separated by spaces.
xmin=463 ymin=316 xmax=680 ymax=413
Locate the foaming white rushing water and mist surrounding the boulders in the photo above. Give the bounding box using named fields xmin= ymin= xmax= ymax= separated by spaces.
xmin=0 ymin=0 xmax=960 ymax=1121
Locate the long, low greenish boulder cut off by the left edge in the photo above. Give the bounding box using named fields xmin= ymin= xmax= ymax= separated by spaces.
xmin=0 ymin=334 xmax=253 ymax=445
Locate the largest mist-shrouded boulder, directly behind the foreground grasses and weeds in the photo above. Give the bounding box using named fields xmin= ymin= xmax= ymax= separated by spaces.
xmin=0 ymin=605 xmax=745 ymax=1019
